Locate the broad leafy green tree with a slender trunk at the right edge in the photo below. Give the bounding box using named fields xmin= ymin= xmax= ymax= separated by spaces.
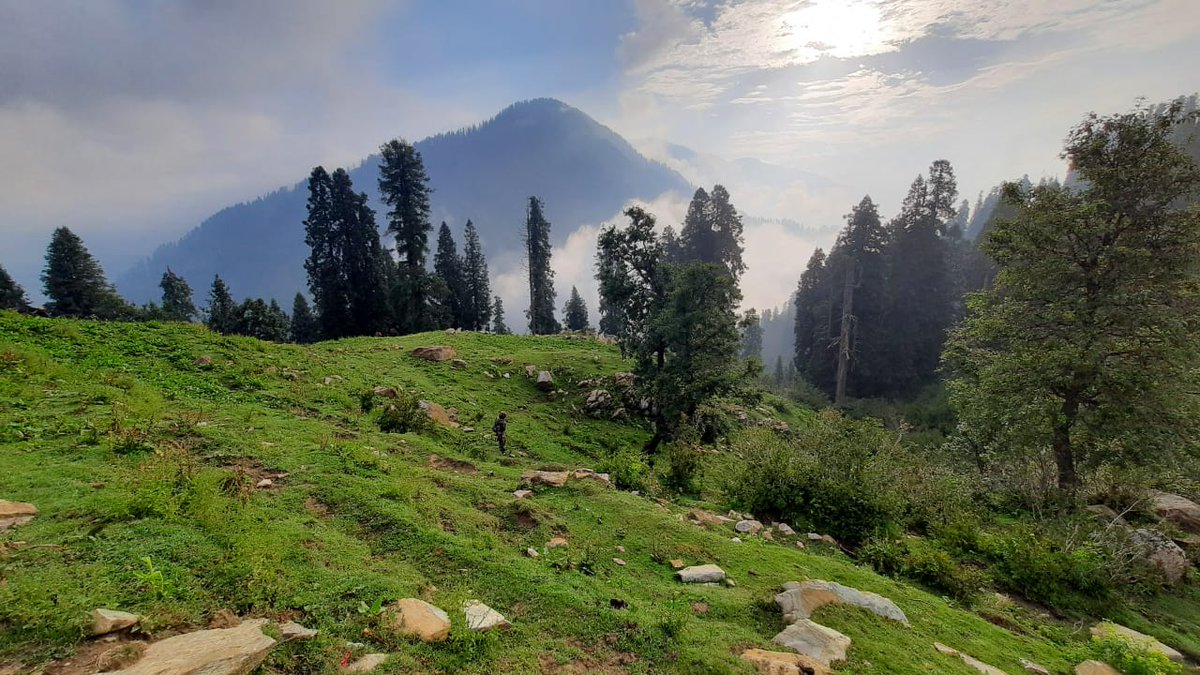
xmin=946 ymin=104 xmax=1200 ymax=502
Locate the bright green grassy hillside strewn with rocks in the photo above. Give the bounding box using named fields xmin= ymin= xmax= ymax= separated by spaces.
xmin=0 ymin=313 xmax=1171 ymax=673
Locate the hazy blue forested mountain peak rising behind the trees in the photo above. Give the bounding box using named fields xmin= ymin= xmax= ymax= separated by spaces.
xmin=118 ymin=98 xmax=692 ymax=303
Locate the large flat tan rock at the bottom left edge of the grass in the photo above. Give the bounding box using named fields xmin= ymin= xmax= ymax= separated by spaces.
xmin=106 ymin=619 xmax=275 ymax=675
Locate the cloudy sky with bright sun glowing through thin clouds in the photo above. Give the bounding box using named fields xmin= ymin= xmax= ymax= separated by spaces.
xmin=0 ymin=0 xmax=1200 ymax=307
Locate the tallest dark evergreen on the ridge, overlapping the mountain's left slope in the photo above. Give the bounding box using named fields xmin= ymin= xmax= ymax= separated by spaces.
xmin=379 ymin=139 xmax=434 ymax=334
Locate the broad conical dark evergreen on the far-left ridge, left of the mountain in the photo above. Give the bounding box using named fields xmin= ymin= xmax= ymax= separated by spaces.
xmin=42 ymin=227 xmax=127 ymax=319
